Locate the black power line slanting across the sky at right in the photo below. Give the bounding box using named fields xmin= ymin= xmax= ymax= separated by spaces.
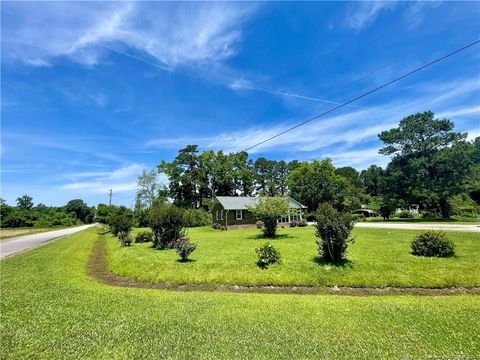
xmin=242 ymin=40 xmax=480 ymax=152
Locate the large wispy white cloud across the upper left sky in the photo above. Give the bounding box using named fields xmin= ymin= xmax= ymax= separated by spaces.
xmin=2 ymin=2 xmax=254 ymax=68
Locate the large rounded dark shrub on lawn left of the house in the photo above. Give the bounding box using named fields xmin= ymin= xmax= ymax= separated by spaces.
xmin=148 ymin=205 xmax=185 ymax=250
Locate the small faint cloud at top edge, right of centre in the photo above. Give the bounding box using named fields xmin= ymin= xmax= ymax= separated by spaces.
xmin=344 ymin=1 xmax=397 ymax=30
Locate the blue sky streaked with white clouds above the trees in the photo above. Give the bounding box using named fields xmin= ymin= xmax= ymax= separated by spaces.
xmin=1 ymin=2 xmax=480 ymax=205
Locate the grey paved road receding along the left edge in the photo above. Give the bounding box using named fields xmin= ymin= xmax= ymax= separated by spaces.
xmin=0 ymin=224 xmax=95 ymax=259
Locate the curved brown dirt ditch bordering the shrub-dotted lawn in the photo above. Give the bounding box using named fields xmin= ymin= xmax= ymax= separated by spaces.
xmin=87 ymin=235 xmax=480 ymax=296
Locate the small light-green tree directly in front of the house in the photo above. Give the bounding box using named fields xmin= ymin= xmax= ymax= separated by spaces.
xmin=249 ymin=197 xmax=288 ymax=237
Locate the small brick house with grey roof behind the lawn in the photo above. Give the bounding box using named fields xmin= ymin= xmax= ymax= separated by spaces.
xmin=212 ymin=196 xmax=306 ymax=227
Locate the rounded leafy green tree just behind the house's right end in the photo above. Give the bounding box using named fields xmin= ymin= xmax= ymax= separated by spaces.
xmin=288 ymin=159 xmax=346 ymax=212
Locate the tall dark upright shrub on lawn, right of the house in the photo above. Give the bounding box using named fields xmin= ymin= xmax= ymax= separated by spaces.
xmin=316 ymin=203 xmax=355 ymax=262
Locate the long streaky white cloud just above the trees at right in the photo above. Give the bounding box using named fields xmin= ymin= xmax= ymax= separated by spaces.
xmin=146 ymin=80 xmax=480 ymax=156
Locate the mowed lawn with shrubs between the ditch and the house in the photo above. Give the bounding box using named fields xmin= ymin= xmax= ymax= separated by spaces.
xmin=107 ymin=226 xmax=480 ymax=287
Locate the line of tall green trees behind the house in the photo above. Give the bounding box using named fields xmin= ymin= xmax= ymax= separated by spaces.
xmin=136 ymin=111 xmax=480 ymax=218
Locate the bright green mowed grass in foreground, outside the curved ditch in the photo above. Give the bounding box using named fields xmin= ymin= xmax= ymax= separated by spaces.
xmin=0 ymin=229 xmax=480 ymax=359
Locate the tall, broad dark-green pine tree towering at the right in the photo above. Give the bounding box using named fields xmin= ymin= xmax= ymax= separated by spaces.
xmin=379 ymin=111 xmax=474 ymax=219
